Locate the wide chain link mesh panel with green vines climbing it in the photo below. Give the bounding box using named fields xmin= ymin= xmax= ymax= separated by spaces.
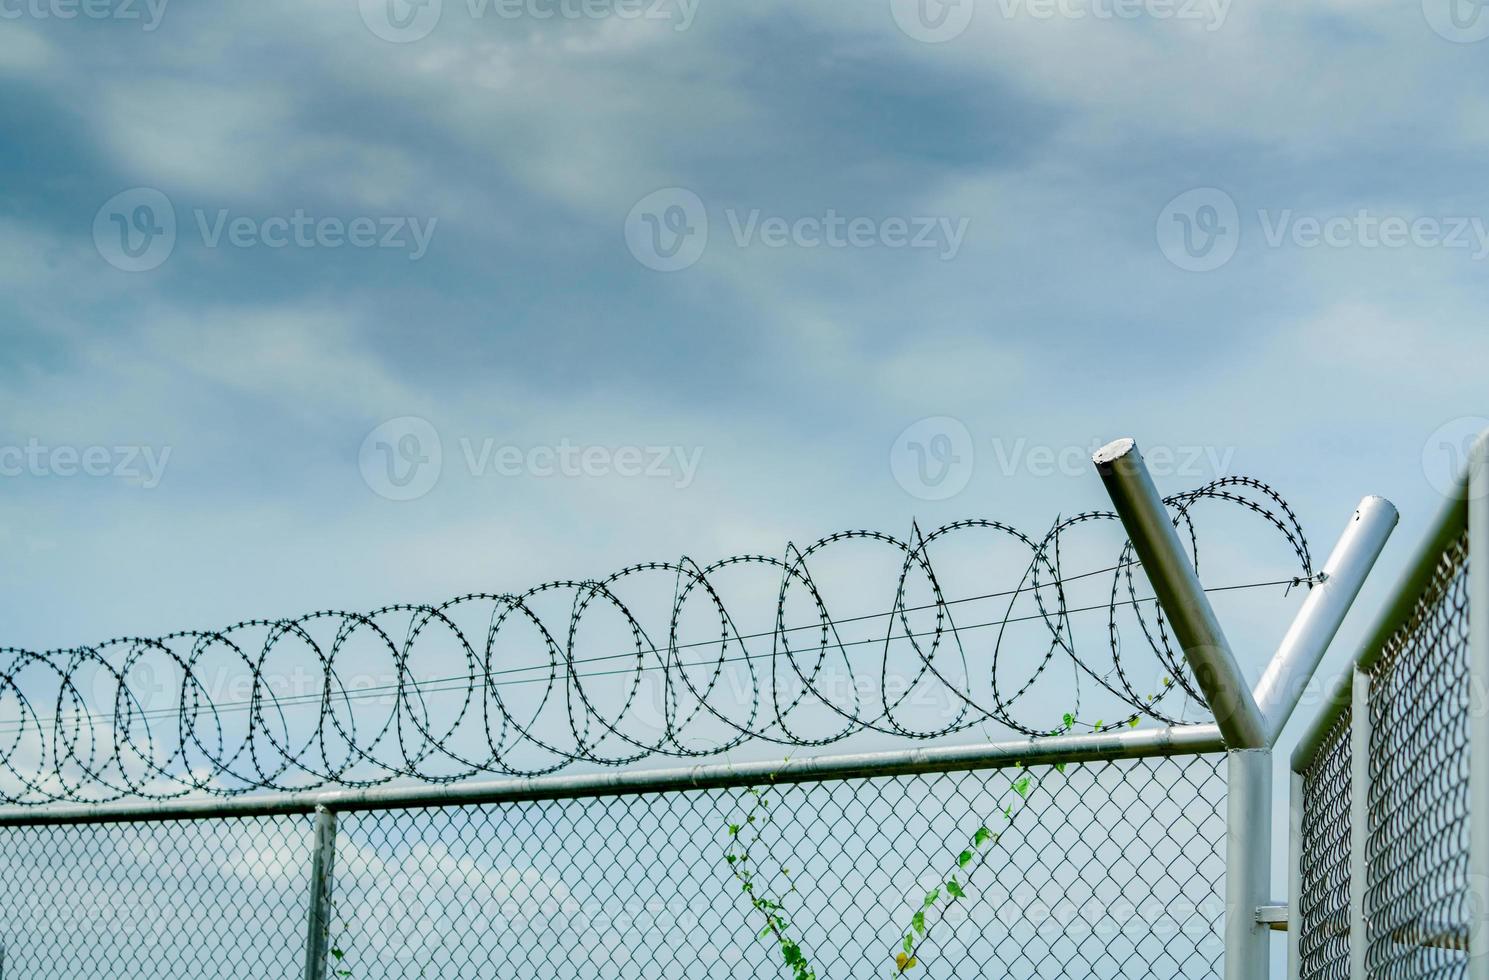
xmin=323 ymin=757 xmax=1225 ymax=980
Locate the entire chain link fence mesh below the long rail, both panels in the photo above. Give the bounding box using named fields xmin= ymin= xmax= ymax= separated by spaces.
xmin=0 ymin=755 xmax=1225 ymax=980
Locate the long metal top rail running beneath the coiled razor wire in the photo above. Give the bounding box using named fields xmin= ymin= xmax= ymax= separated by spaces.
xmin=0 ymin=724 xmax=1225 ymax=827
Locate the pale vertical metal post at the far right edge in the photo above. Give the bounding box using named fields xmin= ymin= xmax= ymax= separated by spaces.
xmin=1468 ymin=433 xmax=1489 ymax=980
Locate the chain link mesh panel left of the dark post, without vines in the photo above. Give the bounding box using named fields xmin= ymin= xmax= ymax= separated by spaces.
xmin=0 ymin=816 xmax=313 ymax=980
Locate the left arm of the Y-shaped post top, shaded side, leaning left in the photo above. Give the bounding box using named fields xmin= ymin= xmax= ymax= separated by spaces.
xmin=1091 ymin=439 xmax=1270 ymax=749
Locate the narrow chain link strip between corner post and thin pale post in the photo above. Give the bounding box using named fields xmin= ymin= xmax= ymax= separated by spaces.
xmin=1298 ymin=709 xmax=1352 ymax=980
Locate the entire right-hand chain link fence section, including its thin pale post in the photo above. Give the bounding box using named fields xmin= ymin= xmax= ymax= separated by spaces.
xmin=1294 ymin=517 xmax=1476 ymax=980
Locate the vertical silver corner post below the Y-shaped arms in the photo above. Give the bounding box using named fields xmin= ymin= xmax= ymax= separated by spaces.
xmin=1225 ymin=749 xmax=1272 ymax=980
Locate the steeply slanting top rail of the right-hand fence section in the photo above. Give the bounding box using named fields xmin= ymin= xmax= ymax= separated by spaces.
xmin=1292 ymin=475 xmax=1468 ymax=773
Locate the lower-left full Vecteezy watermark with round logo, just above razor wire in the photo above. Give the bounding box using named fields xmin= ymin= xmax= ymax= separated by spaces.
xmin=357 ymin=416 xmax=703 ymax=500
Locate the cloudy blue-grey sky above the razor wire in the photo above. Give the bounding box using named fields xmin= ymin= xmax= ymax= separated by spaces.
xmin=0 ymin=0 xmax=1489 ymax=756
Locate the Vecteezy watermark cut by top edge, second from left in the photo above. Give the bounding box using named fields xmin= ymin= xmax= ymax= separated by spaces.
xmin=357 ymin=0 xmax=701 ymax=43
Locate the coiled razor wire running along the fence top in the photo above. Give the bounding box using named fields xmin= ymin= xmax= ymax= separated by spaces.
xmin=0 ymin=477 xmax=1316 ymax=806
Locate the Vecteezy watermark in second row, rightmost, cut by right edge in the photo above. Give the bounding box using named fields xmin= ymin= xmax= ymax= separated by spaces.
xmin=1157 ymin=188 xmax=1489 ymax=273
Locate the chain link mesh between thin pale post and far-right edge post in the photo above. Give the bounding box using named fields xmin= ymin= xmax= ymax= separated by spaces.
xmin=1365 ymin=535 xmax=1471 ymax=980
